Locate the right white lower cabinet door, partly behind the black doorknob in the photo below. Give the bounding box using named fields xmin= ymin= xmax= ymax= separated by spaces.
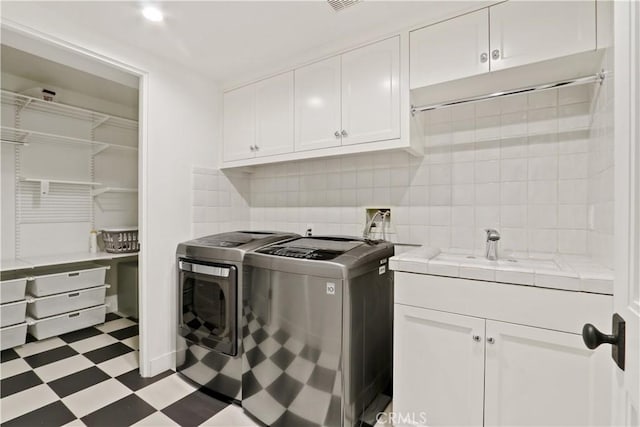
xmin=485 ymin=320 xmax=612 ymax=426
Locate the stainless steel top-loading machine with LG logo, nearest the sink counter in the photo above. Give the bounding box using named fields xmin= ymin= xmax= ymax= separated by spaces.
xmin=242 ymin=236 xmax=393 ymax=426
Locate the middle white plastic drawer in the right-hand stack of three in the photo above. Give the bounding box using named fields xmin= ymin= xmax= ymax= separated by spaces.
xmin=27 ymin=285 xmax=109 ymax=319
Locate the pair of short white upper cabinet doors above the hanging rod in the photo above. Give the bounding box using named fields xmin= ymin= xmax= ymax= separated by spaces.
xmin=409 ymin=0 xmax=596 ymax=89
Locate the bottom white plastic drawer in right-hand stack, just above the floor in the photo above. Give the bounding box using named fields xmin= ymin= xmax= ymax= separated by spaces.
xmin=27 ymin=305 xmax=107 ymax=340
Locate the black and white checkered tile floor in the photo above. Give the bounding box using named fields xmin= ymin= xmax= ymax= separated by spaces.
xmin=0 ymin=313 xmax=256 ymax=427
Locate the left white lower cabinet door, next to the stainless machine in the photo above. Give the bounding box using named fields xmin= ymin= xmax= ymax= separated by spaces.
xmin=393 ymin=304 xmax=485 ymax=426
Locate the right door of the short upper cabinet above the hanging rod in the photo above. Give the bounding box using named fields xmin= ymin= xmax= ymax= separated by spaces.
xmin=489 ymin=0 xmax=596 ymax=70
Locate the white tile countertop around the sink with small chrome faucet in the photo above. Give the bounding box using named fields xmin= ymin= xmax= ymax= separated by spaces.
xmin=389 ymin=246 xmax=613 ymax=295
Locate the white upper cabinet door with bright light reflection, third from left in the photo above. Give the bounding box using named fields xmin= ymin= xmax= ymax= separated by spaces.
xmin=295 ymin=56 xmax=342 ymax=151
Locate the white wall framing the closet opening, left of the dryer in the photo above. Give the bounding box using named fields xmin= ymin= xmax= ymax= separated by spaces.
xmin=2 ymin=2 xmax=220 ymax=375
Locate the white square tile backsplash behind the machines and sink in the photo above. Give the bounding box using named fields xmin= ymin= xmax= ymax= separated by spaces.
xmin=194 ymin=68 xmax=613 ymax=258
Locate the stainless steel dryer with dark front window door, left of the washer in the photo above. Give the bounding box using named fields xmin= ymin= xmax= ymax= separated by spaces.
xmin=176 ymin=231 xmax=299 ymax=401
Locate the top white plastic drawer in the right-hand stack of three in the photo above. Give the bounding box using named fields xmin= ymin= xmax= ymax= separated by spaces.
xmin=27 ymin=266 xmax=109 ymax=297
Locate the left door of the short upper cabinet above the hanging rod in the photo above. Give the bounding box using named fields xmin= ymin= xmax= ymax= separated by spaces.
xmin=409 ymin=8 xmax=490 ymax=89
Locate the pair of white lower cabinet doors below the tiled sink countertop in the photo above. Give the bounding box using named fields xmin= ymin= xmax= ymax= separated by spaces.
xmin=394 ymin=304 xmax=611 ymax=426
